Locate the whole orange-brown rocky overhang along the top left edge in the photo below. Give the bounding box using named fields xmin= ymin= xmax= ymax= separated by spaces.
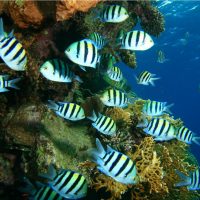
xmin=0 ymin=0 xmax=100 ymax=28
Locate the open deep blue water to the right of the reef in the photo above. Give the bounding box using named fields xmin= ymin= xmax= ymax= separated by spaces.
xmin=122 ymin=0 xmax=200 ymax=163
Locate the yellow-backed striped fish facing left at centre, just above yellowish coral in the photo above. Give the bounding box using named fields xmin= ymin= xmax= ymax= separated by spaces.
xmin=100 ymin=89 xmax=129 ymax=108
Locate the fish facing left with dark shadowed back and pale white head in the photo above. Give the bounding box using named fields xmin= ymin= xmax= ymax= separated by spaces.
xmin=40 ymin=59 xmax=83 ymax=83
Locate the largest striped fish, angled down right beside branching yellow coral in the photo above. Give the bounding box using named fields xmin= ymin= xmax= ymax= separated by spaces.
xmin=90 ymin=139 xmax=138 ymax=184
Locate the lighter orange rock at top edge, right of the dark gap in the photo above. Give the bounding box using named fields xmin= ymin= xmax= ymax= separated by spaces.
xmin=56 ymin=0 xmax=100 ymax=21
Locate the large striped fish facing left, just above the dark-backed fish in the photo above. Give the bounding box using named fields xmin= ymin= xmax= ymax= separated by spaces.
xmin=65 ymin=39 xmax=100 ymax=70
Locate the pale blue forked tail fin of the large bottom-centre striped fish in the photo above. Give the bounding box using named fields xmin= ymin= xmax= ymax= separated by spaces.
xmin=89 ymin=138 xmax=106 ymax=163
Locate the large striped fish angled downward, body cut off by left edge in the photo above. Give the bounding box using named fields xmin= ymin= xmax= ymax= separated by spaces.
xmin=0 ymin=18 xmax=27 ymax=71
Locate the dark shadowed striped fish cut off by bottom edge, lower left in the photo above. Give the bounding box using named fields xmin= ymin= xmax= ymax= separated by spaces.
xmin=20 ymin=178 xmax=65 ymax=200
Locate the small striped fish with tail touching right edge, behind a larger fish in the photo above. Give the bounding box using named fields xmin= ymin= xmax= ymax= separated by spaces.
xmin=176 ymin=126 xmax=200 ymax=145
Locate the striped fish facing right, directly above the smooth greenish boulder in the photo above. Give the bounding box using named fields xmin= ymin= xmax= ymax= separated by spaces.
xmin=48 ymin=100 xmax=85 ymax=121
